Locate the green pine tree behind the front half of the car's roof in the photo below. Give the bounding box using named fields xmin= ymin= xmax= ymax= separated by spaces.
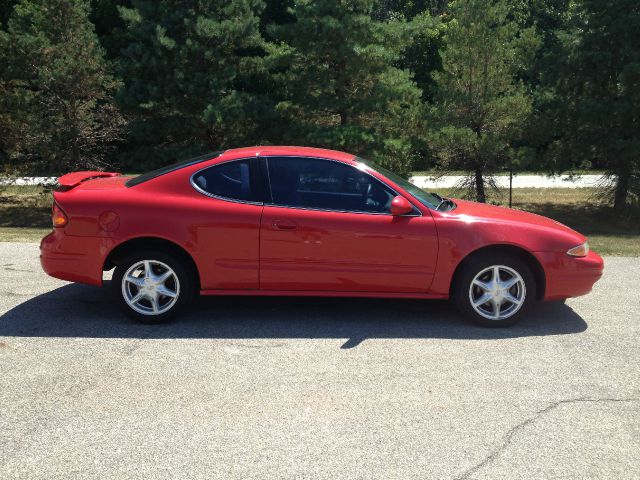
xmin=270 ymin=0 xmax=421 ymax=174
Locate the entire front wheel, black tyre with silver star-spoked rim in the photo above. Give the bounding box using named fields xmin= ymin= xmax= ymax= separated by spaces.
xmin=452 ymin=253 xmax=536 ymax=327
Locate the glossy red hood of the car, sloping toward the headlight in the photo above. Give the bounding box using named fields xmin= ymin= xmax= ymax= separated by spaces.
xmin=449 ymin=199 xmax=586 ymax=242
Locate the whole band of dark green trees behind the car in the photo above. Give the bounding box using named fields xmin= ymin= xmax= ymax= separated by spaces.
xmin=0 ymin=0 xmax=640 ymax=211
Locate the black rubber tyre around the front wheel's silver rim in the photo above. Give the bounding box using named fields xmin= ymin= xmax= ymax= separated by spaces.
xmin=452 ymin=252 xmax=536 ymax=328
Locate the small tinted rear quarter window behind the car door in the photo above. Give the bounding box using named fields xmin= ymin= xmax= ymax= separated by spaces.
xmin=193 ymin=159 xmax=254 ymax=201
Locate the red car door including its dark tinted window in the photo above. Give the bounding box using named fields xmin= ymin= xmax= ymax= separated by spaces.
xmin=260 ymin=157 xmax=438 ymax=293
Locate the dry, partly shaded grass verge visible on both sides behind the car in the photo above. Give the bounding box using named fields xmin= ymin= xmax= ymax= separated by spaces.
xmin=0 ymin=186 xmax=640 ymax=256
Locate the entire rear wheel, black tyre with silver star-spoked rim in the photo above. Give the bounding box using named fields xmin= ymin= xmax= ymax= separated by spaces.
xmin=112 ymin=250 xmax=195 ymax=324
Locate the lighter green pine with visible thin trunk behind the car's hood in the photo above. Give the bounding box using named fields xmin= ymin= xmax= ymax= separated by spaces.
xmin=430 ymin=0 xmax=537 ymax=202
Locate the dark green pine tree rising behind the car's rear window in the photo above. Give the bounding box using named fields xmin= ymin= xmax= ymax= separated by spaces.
xmin=119 ymin=0 xmax=268 ymax=168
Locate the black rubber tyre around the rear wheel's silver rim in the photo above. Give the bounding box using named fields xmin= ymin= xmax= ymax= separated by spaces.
xmin=111 ymin=250 xmax=196 ymax=324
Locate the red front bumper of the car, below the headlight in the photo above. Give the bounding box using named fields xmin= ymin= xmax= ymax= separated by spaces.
xmin=536 ymin=252 xmax=604 ymax=300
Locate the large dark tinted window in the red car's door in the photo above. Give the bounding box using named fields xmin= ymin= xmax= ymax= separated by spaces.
xmin=267 ymin=157 xmax=395 ymax=213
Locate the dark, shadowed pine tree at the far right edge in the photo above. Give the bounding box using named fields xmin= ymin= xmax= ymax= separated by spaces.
xmin=550 ymin=0 xmax=640 ymax=211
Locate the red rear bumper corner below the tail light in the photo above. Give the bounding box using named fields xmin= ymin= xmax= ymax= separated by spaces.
xmin=40 ymin=228 xmax=109 ymax=286
